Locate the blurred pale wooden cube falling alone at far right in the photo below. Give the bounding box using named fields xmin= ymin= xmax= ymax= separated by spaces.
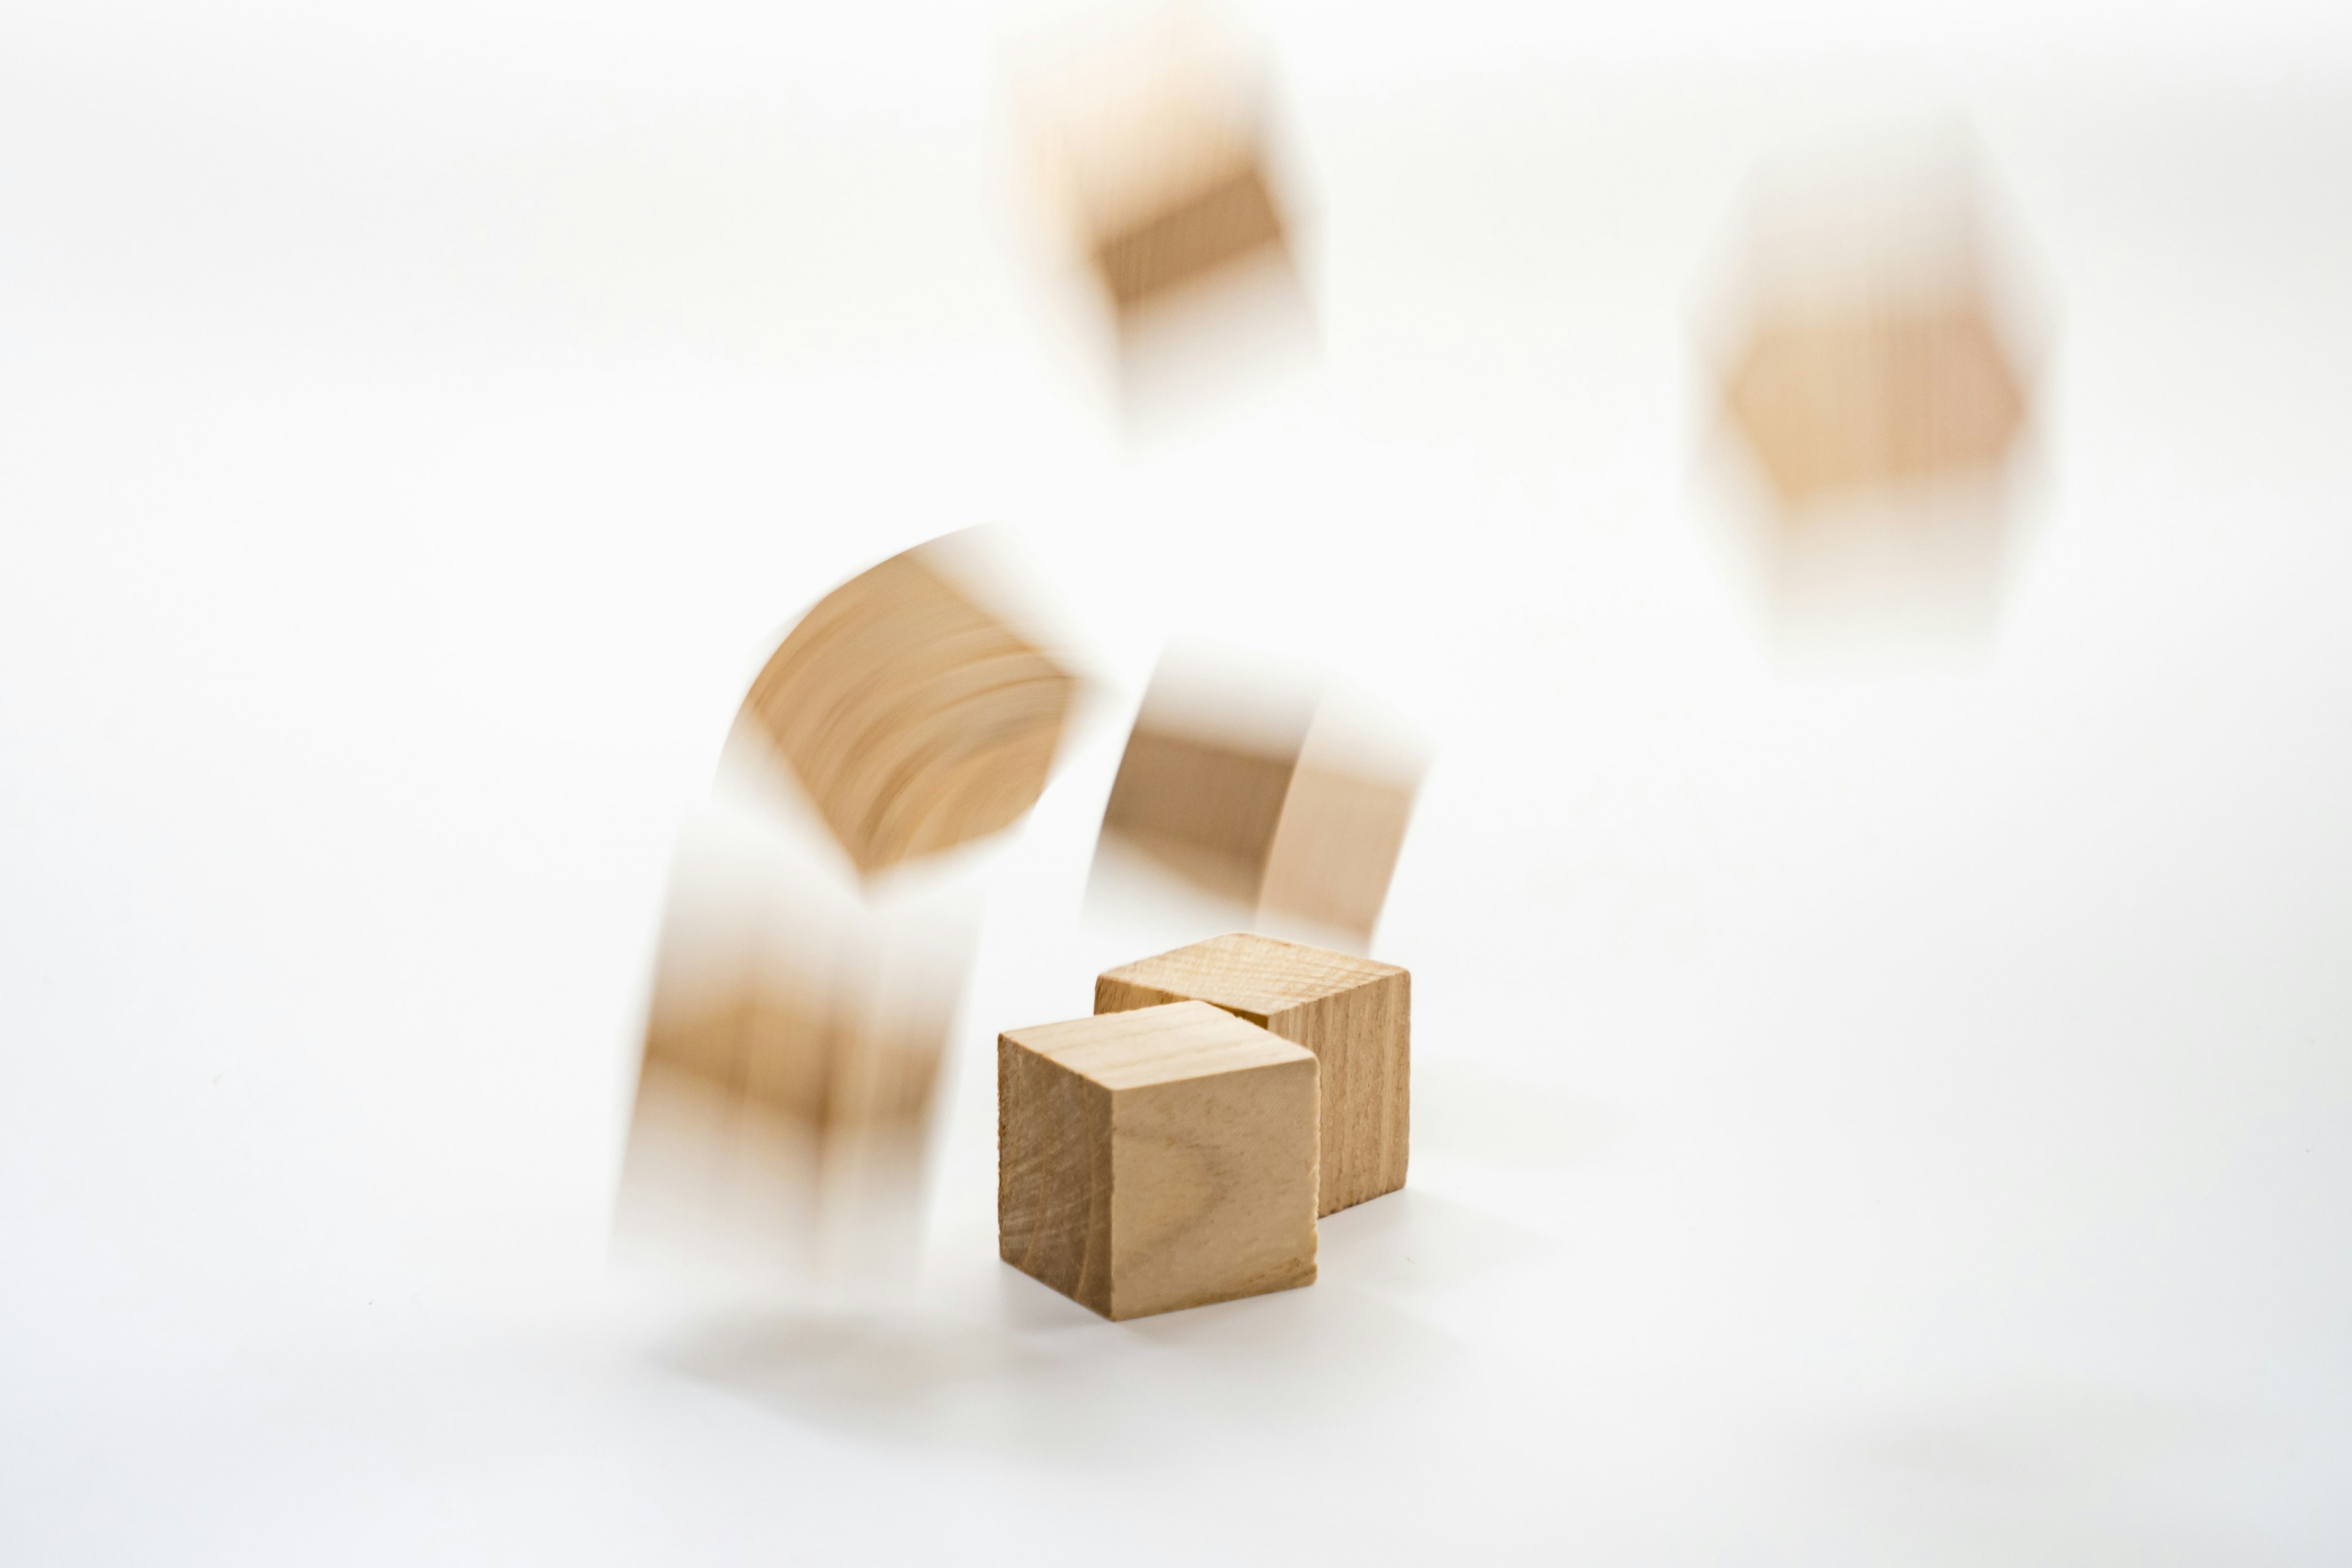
xmin=1700 ymin=129 xmax=2041 ymax=646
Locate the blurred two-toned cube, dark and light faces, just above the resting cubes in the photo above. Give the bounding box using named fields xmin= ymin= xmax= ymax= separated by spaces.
xmin=1096 ymin=656 xmax=1425 ymax=943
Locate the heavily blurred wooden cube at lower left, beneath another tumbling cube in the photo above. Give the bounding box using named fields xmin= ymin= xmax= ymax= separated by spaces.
xmin=616 ymin=809 xmax=978 ymax=1281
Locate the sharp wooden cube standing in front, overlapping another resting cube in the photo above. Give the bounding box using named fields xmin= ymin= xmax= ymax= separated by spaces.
xmin=997 ymin=1001 xmax=1317 ymax=1319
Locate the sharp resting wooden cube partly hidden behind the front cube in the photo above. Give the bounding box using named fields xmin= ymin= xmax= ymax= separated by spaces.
xmin=1094 ymin=933 xmax=1414 ymax=1215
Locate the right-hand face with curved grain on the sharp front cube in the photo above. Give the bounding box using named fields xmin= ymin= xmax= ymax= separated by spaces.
xmin=1108 ymin=1058 xmax=1322 ymax=1319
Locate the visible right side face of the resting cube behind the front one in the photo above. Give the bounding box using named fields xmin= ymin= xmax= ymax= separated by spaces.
xmin=1265 ymin=968 xmax=1414 ymax=1213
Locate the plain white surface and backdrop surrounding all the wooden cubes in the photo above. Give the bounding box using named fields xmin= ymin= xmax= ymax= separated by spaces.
xmin=0 ymin=5 xmax=2352 ymax=1566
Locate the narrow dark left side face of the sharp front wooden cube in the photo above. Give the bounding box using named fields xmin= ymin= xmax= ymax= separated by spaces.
xmin=997 ymin=1035 xmax=1112 ymax=1316
